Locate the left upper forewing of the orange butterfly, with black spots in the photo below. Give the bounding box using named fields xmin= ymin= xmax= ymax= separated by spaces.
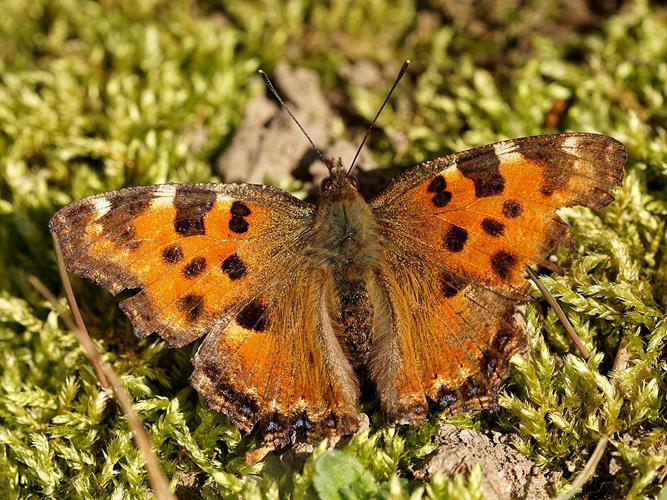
xmin=50 ymin=184 xmax=311 ymax=347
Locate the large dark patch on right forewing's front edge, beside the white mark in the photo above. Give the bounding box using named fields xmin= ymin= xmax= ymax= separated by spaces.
xmin=456 ymin=145 xmax=505 ymax=198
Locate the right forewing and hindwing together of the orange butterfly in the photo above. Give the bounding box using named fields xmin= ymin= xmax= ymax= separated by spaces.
xmin=370 ymin=133 xmax=626 ymax=421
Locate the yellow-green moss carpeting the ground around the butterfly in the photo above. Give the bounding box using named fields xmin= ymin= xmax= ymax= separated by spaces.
xmin=0 ymin=0 xmax=667 ymax=498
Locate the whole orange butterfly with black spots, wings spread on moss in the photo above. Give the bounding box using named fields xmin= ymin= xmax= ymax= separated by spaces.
xmin=50 ymin=63 xmax=626 ymax=454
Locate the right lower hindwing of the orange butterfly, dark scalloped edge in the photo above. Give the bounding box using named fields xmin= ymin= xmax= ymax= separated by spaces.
xmin=370 ymin=258 xmax=526 ymax=424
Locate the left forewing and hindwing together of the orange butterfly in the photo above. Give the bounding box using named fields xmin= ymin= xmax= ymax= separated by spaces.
xmin=50 ymin=184 xmax=357 ymax=439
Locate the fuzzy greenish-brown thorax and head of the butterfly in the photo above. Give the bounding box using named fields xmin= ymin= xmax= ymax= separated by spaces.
xmin=313 ymin=169 xmax=381 ymax=278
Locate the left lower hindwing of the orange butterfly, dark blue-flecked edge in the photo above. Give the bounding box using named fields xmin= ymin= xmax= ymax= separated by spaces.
xmin=192 ymin=273 xmax=359 ymax=448
